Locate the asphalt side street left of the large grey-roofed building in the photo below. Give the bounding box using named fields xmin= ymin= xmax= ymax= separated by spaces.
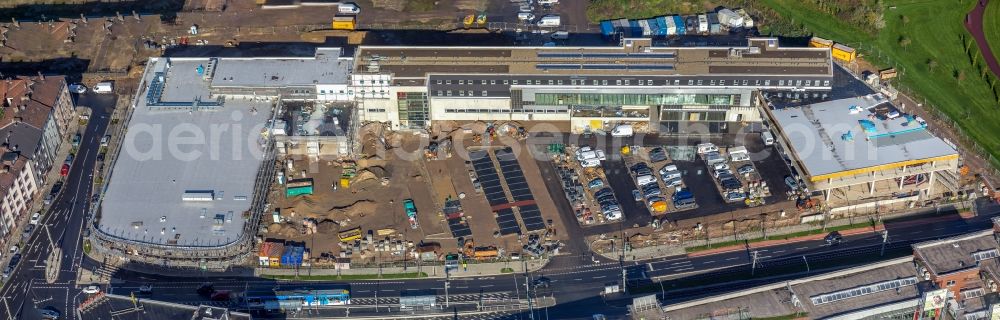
xmin=0 ymin=94 xmax=116 ymax=319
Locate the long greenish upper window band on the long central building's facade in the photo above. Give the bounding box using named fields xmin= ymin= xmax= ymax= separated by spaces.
xmin=535 ymin=93 xmax=739 ymax=106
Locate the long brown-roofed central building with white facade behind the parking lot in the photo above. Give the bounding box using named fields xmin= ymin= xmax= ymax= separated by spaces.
xmin=351 ymin=38 xmax=833 ymax=133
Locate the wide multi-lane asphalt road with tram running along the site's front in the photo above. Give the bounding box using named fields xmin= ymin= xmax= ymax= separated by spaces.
xmin=88 ymin=201 xmax=995 ymax=319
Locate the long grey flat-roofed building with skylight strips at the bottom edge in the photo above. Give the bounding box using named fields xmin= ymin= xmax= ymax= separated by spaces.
xmin=664 ymin=258 xmax=935 ymax=320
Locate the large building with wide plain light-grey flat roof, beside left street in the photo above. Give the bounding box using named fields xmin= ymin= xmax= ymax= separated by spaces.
xmin=94 ymin=48 xmax=352 ymax=268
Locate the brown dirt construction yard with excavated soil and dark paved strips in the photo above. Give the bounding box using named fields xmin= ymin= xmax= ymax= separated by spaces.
xmin=261 ymin=119 xmax=563 ymax=267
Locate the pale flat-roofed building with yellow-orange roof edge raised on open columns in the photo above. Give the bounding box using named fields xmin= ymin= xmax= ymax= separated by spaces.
xmin=762 ymin=94 xmax=959 ymax=210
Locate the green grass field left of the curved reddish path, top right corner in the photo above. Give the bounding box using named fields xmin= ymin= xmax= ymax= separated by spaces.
xmin=759 ymin=0 xmax=1000 ymax=166
